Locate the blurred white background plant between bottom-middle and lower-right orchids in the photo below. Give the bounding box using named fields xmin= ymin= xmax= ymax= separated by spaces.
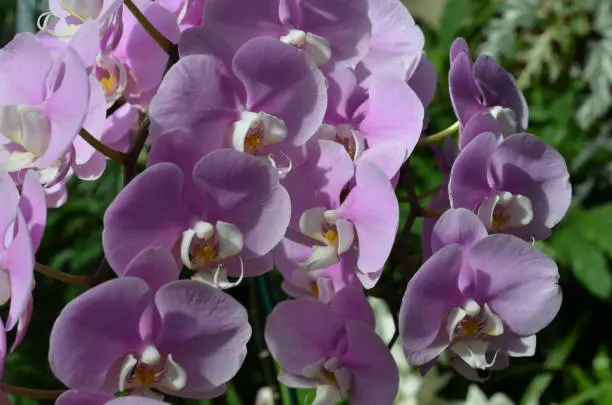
xmin=368 ymin=297 xmax=452 ymax=405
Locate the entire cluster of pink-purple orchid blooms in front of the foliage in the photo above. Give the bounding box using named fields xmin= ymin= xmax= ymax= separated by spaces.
xmin=0 ymin=0 xmax=571 ymax=405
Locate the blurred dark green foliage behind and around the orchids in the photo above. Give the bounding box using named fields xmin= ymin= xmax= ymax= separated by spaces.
xmin=0 ymin=0 xmax=612 ymax=405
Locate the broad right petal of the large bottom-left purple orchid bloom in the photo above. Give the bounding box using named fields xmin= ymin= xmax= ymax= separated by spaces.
xmin=155 ymin=280 xmax=251 ymax=398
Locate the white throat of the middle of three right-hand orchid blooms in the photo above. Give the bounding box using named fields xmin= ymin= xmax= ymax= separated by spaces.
xmin=477 ymin=191 xmax=533 ymax=232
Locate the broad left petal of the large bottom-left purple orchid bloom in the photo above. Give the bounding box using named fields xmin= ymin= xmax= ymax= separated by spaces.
xmin=49 ymin=277 xmax=153 ymax=394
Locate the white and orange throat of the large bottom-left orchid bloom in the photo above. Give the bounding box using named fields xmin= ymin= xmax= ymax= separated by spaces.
xmin=119 ymin=346 xmax=187 ymax=397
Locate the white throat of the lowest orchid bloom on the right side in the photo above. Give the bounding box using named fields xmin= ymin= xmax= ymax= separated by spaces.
xmin=446 ymin=299 xmax=504 ymax=370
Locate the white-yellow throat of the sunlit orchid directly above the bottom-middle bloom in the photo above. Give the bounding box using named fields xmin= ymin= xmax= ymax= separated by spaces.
xmin=300 ymin=207 xmax=355 ymax=271
